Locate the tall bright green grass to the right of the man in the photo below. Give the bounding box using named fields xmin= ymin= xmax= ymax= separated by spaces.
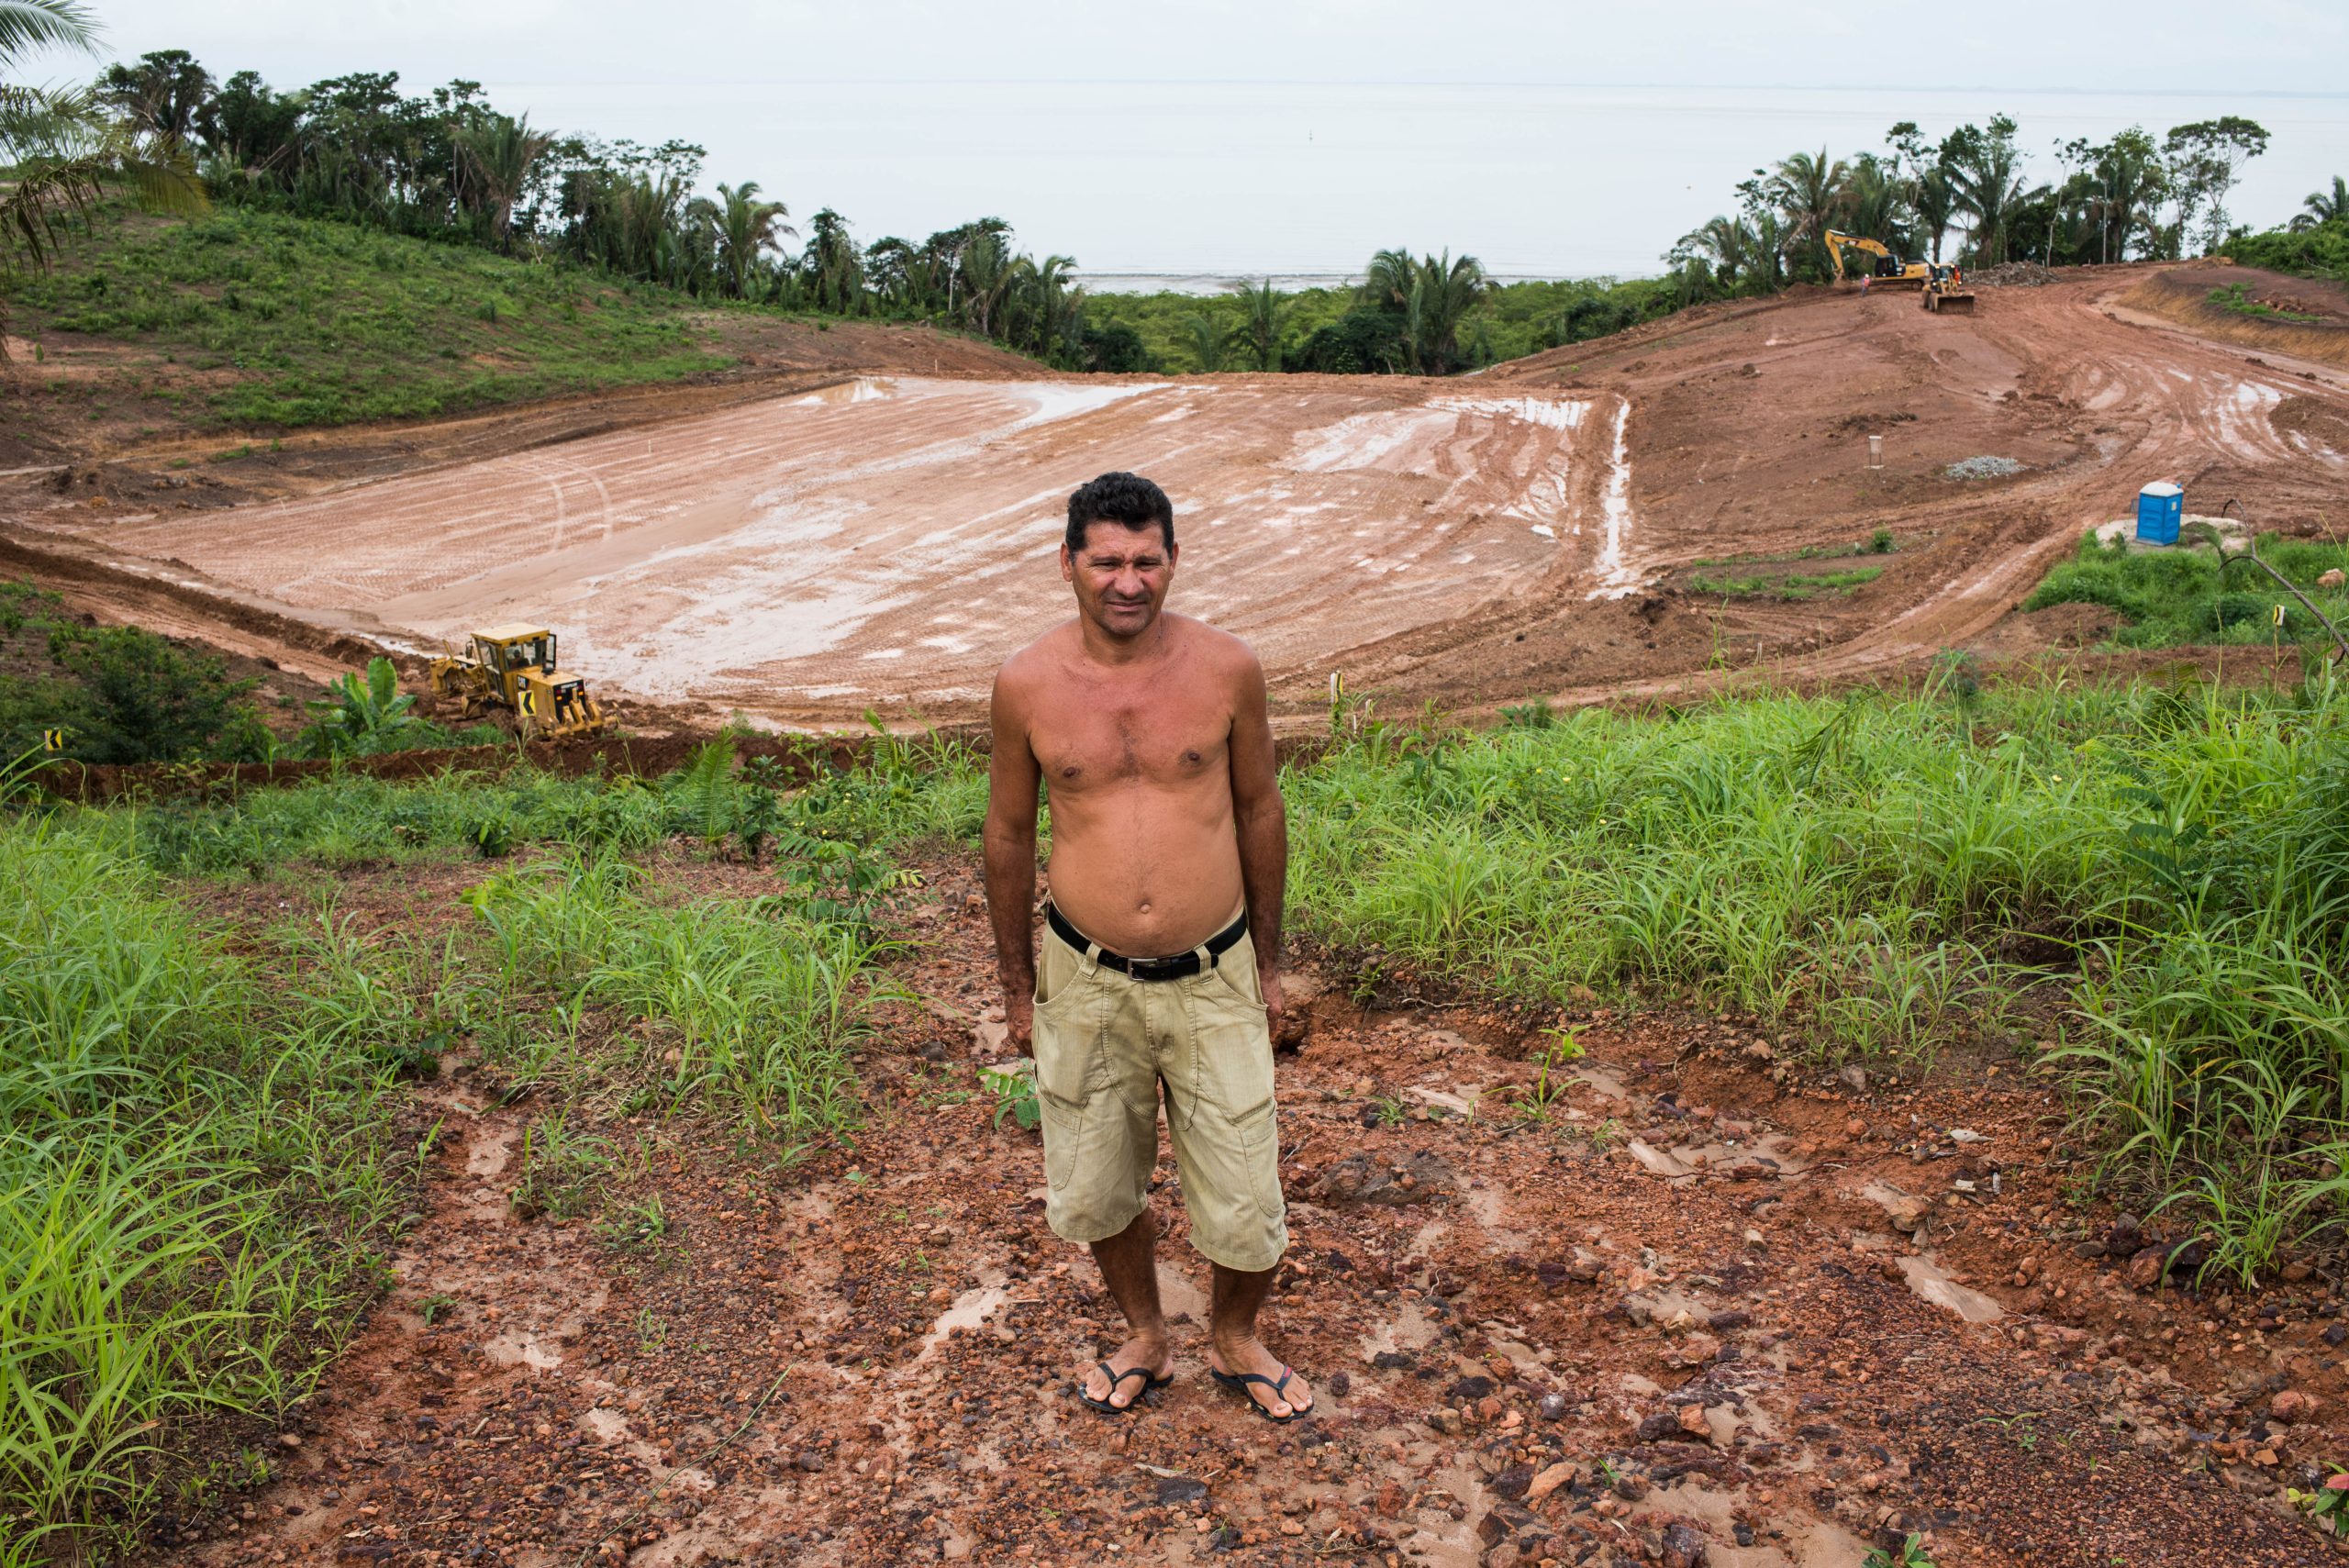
xmin=1287 ymin=676 xmax=2349 ymax=1273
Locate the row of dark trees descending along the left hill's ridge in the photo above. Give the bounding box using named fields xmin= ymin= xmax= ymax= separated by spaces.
xmin=68 ymin=50 xmax=1141 ymax=369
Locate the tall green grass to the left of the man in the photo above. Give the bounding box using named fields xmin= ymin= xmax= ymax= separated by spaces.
xmin=0 ymin=741 xmax=985 ymax=1568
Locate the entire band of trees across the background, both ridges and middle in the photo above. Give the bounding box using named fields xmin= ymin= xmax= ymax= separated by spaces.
xmin=0 ymin=34 xmax=2349 ymax=375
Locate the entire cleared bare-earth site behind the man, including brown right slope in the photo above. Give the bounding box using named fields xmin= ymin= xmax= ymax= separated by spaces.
xmin=14 ymin=268 xmax=2349 ymax=726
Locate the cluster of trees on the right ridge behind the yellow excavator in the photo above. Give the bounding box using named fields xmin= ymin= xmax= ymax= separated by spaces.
xmin=1665 ymin=115 xmax=2266 ymax=298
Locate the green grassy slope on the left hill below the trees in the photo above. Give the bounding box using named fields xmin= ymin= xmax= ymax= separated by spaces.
xmin=12 ymin=209 xmax=730 ymax=428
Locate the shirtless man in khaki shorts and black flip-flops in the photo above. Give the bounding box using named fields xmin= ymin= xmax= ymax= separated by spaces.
xmin=986 ymin=474 xmax=1313 ymax=1420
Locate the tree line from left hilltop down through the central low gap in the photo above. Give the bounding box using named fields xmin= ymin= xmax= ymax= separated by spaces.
xmin=55 ymin=50 xmax=1668 ymax=375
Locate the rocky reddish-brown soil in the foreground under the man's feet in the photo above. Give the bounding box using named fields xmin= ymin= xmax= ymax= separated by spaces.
xmin=165 ymin=862 xmax=2349 ymax=1568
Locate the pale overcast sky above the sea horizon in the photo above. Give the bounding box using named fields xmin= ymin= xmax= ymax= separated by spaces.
xmin=32 ymin=0 xmax=2349 ymax=94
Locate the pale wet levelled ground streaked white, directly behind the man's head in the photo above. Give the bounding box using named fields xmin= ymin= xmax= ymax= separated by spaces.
xmin=18 ymin=378 xmax=1632 ymax=711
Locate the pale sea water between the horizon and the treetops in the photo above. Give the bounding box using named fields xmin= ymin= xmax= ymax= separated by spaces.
xmin=488 ymin=83 xmax=2349 ymax=283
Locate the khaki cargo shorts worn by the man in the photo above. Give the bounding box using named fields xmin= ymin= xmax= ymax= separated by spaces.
xmin=1036 ymin=906 xmax=1289 ymax=1274
